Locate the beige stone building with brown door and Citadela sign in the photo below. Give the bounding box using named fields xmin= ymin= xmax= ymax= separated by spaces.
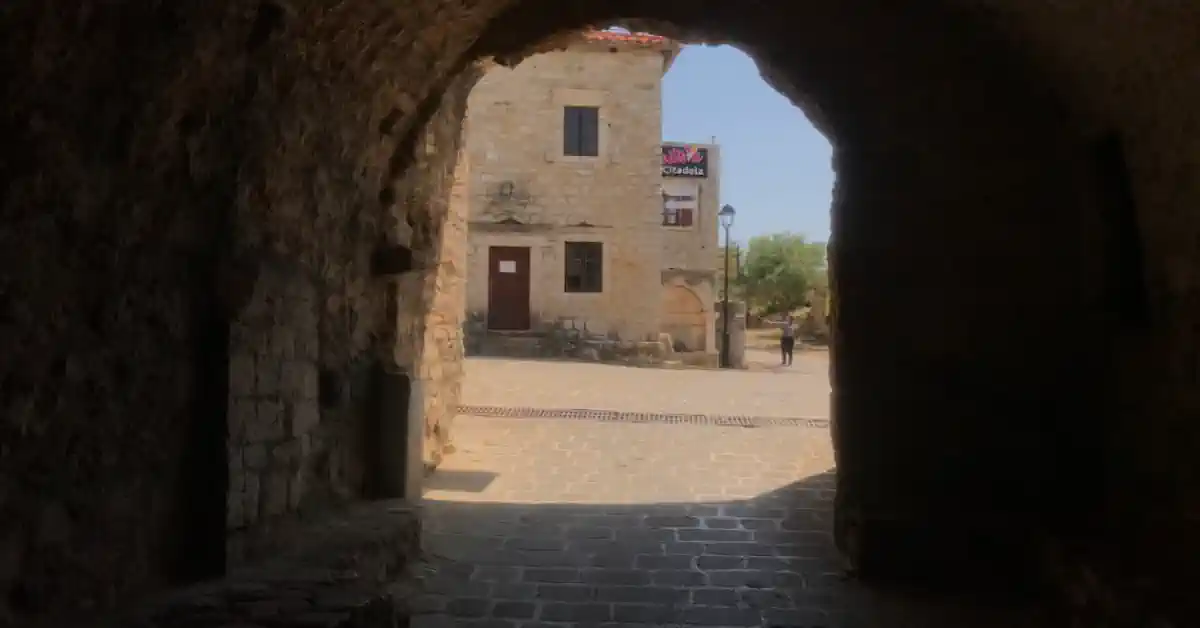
xmin=466 ymin=31 xmax=719 ymax=351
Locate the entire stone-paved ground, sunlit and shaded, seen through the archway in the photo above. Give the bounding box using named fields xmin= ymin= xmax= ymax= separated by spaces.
xmin=413 ymin=355 xmax=1036 ymax=628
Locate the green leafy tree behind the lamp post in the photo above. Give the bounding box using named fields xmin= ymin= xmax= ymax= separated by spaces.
xmin=737 ymin=232 xmax=826 ymax=316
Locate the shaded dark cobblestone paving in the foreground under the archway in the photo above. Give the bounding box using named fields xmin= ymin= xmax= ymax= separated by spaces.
xmin=408 ymin=469 xmax=1042 ymax=628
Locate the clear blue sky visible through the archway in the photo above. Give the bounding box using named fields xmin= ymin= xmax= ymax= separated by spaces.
xmin=662 ymin=46 xmax=833 ymax=243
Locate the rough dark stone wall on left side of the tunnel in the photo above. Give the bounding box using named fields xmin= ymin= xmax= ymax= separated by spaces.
xmin=0 ymin=0 xmax=484 ymax=623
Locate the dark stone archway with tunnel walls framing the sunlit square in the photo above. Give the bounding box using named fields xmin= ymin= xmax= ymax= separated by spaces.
xmin=0 ymin=0 xmax=1200 ymax=617
